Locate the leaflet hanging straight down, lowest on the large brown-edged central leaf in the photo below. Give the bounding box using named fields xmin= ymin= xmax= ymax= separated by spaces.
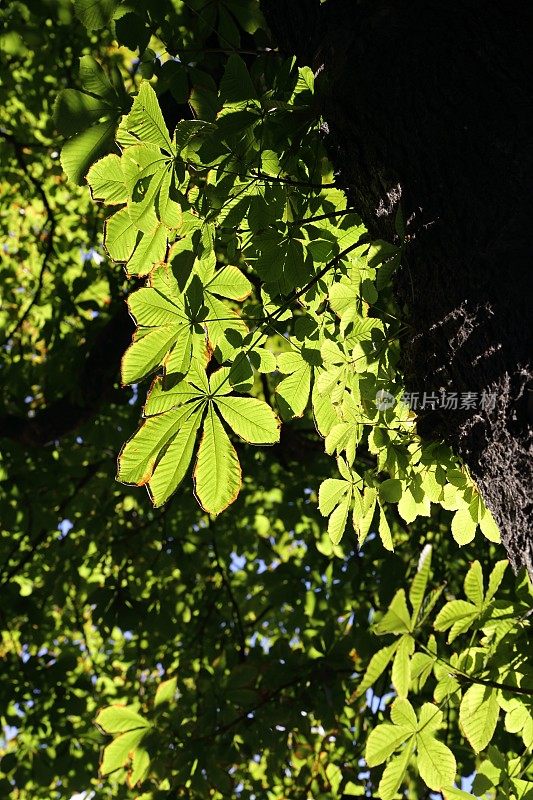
xmin=194 ymin=405 xmax=241 ymax=515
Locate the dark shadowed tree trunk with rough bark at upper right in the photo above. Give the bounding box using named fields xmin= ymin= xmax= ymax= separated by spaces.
xmin=263 ymin=0 xmax=533 ymax=574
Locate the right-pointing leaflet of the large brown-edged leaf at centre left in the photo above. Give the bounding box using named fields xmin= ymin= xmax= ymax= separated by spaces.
xmin=215 ymin=396 xmax=280 ymax=444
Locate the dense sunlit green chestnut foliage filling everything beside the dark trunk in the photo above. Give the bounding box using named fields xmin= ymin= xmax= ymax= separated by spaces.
xmin=0 ymin=0 xmax=533 ymax=800
